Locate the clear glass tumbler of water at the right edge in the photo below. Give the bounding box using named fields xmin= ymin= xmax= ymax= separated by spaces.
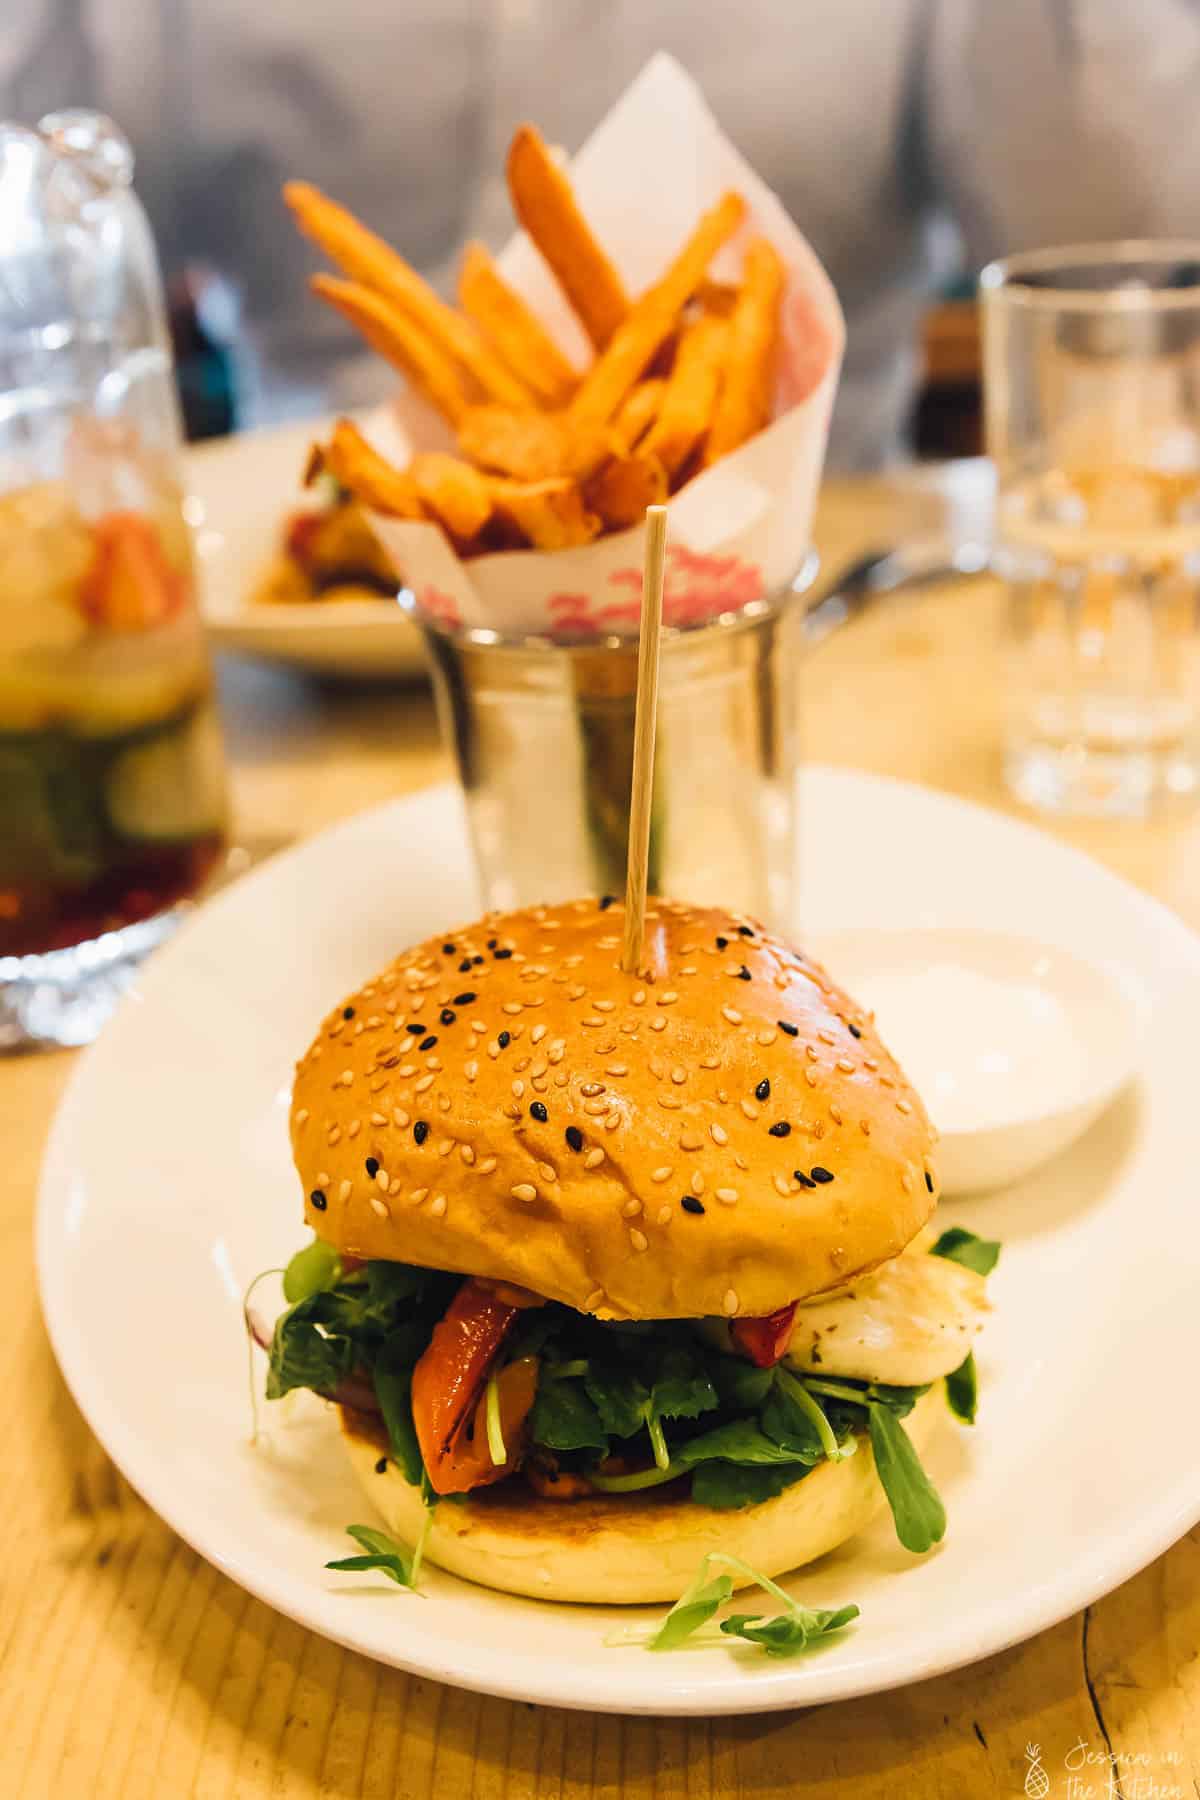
xmin=982 ymin=241 xmax=1200 ymax=817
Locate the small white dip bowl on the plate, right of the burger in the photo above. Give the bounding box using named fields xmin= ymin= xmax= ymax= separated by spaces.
xmin=813 ymin=927 xmax=1148 ymax=1193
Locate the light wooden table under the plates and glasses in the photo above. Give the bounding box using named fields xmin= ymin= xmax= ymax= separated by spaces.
xmin=0 ymin=468 xmax=1200 ymax=1800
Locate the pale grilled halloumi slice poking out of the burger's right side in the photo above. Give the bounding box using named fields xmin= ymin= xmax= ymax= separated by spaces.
xmin=784 ymin=1255 xmax=991 ymax=1388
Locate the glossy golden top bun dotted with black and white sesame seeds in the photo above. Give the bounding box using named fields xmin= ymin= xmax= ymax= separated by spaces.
xmin=291 ymin=900 xmax=937 ymax=1319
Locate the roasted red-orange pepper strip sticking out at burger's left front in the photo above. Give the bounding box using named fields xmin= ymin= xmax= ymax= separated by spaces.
xmin=412 ymin=1282 xmax=518 ymax=1494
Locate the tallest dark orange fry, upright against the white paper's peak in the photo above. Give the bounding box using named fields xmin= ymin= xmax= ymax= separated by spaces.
xmin=507 ymin=124 xmax=630 ymax=349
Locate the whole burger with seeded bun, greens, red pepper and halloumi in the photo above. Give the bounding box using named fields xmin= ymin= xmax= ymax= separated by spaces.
xmin=266 ymin=898 xmax=997 ymax=1602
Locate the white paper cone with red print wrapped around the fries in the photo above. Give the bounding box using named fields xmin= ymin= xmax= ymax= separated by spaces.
xmin=367 ymin=54 xmax=846 ymax=639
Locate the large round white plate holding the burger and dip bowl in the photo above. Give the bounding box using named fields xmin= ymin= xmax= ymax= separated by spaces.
xmin=38 ymin=770 xmax=1200 ymax=1714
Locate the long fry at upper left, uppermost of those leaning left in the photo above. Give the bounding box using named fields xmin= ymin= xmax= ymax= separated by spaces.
xmin=284 ymin=182 xmax=533 ymax=407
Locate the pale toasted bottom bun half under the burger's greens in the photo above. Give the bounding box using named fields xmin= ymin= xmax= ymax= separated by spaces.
xmin=340 ymin=1382 xmax=946 ymax=1606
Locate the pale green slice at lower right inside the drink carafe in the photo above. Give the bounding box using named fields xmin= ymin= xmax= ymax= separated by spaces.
xmin=108 ymin=706 xmax=227 ymax=844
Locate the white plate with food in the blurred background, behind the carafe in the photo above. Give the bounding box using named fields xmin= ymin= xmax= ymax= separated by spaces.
xmin=185 ymin=419 xmax=425 ymax=680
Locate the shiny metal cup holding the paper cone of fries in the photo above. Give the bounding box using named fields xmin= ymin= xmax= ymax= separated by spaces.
xmin=410 ymin=569 xmax=813 ymax=925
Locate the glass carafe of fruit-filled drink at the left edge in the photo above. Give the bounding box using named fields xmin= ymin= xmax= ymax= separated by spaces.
xmin=0 ymin=113 xmax=227 ymax=1048
